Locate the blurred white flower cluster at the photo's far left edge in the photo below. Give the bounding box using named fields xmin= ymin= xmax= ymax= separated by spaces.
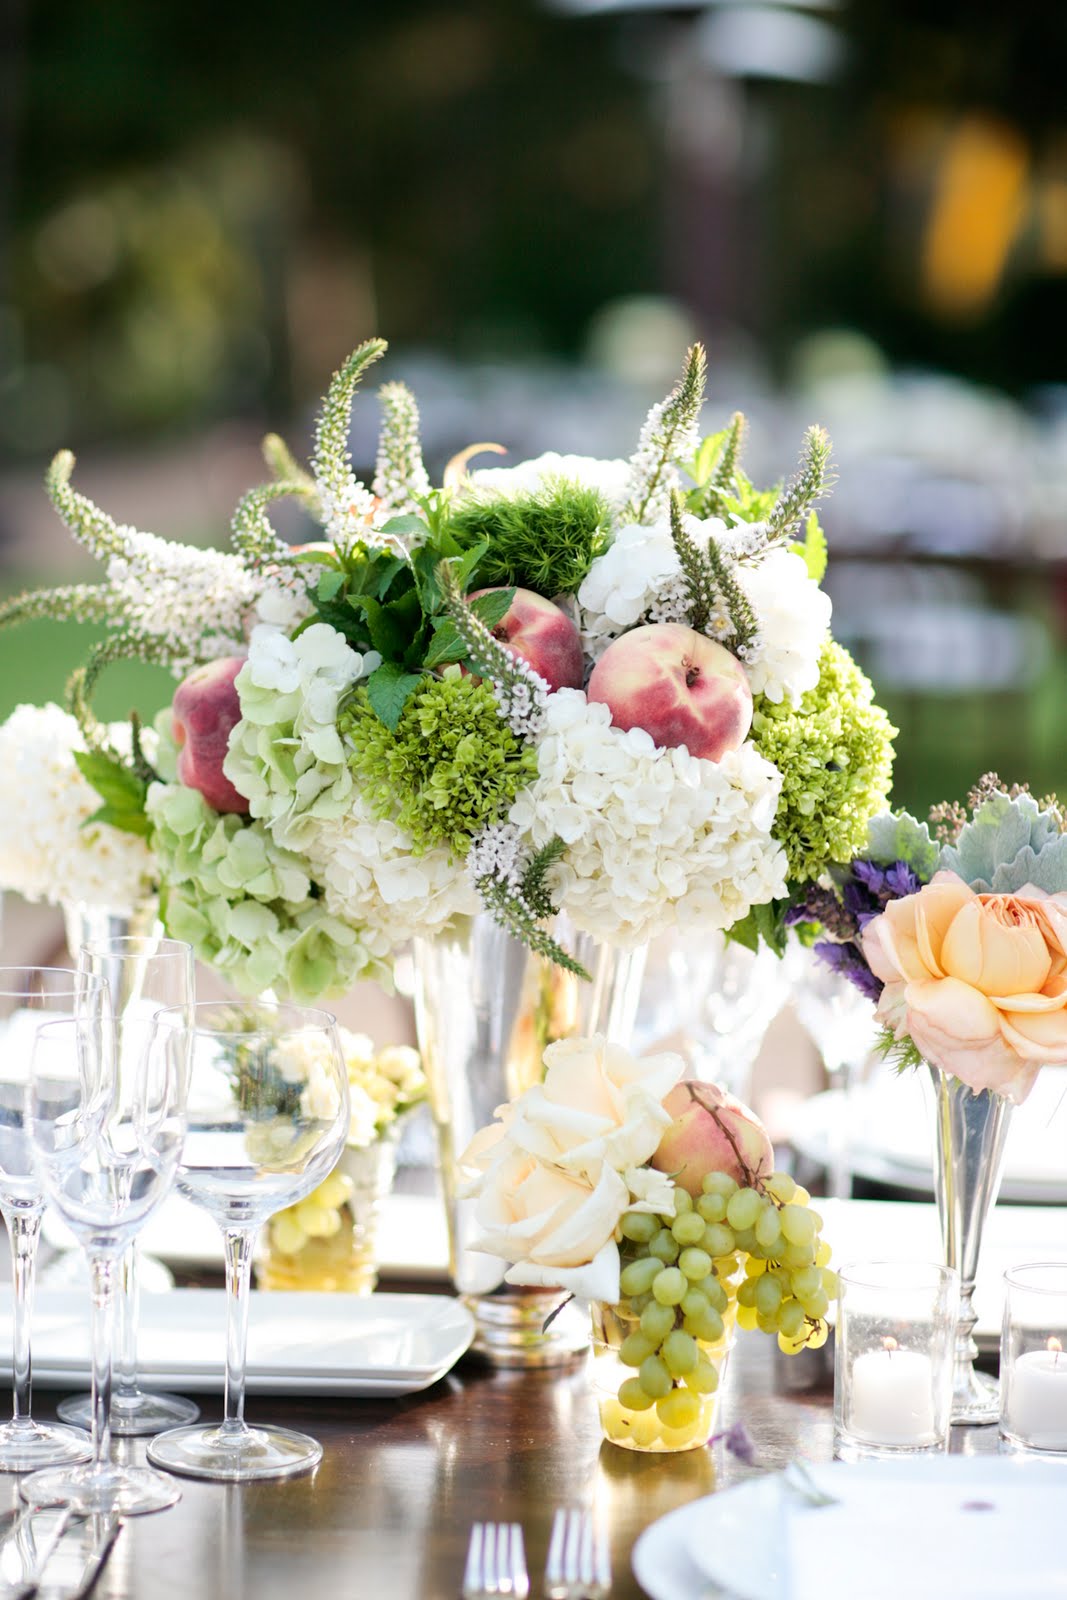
xmin=0 ymin=704 xmax=155 ymax=914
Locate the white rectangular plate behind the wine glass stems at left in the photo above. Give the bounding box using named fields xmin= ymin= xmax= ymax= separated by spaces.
xmin=0 ymin=1290 xmax=474 ymax=1395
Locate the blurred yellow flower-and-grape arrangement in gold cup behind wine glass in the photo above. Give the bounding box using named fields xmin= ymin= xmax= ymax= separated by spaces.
xmin=256 ymin=1027 xmax=426 ymax=1294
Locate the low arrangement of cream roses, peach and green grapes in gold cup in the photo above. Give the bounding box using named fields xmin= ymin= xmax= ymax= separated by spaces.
xmin=461 ymin=1037 xmax=837 ymax=1451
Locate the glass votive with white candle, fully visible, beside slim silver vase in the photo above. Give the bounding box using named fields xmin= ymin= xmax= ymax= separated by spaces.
xmin=833 ymin=1261 xmax=960 ymax=1459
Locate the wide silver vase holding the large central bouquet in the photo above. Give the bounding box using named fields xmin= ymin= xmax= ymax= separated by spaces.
xmin=414 ymin=914 xmax=645 ymax=1366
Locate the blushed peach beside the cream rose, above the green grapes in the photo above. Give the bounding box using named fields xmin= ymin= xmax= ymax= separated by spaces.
xmin=653 ymin=1078 xmax=774 ymax=1197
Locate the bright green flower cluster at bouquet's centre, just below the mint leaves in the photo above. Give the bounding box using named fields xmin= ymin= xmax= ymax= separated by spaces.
xmin=347 ymin=667 xmax=537 ymax=858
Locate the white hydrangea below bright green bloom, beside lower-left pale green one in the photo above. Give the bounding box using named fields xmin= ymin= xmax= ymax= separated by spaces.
xmin=304 ymin=795 xmax=480 ymax=946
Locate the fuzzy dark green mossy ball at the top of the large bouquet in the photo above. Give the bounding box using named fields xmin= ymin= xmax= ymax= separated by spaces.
xmin=448 ymin=478 xmax=608 ymax=598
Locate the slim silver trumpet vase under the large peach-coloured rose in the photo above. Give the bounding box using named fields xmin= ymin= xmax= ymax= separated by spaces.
xmin=929 ymin=1067 xmax=1011 ymax=1424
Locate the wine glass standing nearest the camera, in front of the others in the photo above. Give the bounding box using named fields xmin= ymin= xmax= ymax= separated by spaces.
xmin=21 ymin=1016 xmax=186 ymax=1517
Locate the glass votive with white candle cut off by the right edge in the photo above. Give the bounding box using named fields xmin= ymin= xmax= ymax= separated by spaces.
xmin=1000 ymin=1261 xmax=1067 ymax=1454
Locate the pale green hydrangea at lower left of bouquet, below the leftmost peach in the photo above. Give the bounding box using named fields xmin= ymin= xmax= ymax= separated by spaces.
xmin=146 ymin=784 xmax=389 ymax=1002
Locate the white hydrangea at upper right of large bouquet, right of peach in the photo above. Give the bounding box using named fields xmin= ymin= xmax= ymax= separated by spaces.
xmin=737 ymin=546 xmax=832 ymax=706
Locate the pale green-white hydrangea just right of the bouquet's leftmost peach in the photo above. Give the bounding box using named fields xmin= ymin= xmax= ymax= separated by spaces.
xmin=222 ymin=622 xmax=379 ymax=850
